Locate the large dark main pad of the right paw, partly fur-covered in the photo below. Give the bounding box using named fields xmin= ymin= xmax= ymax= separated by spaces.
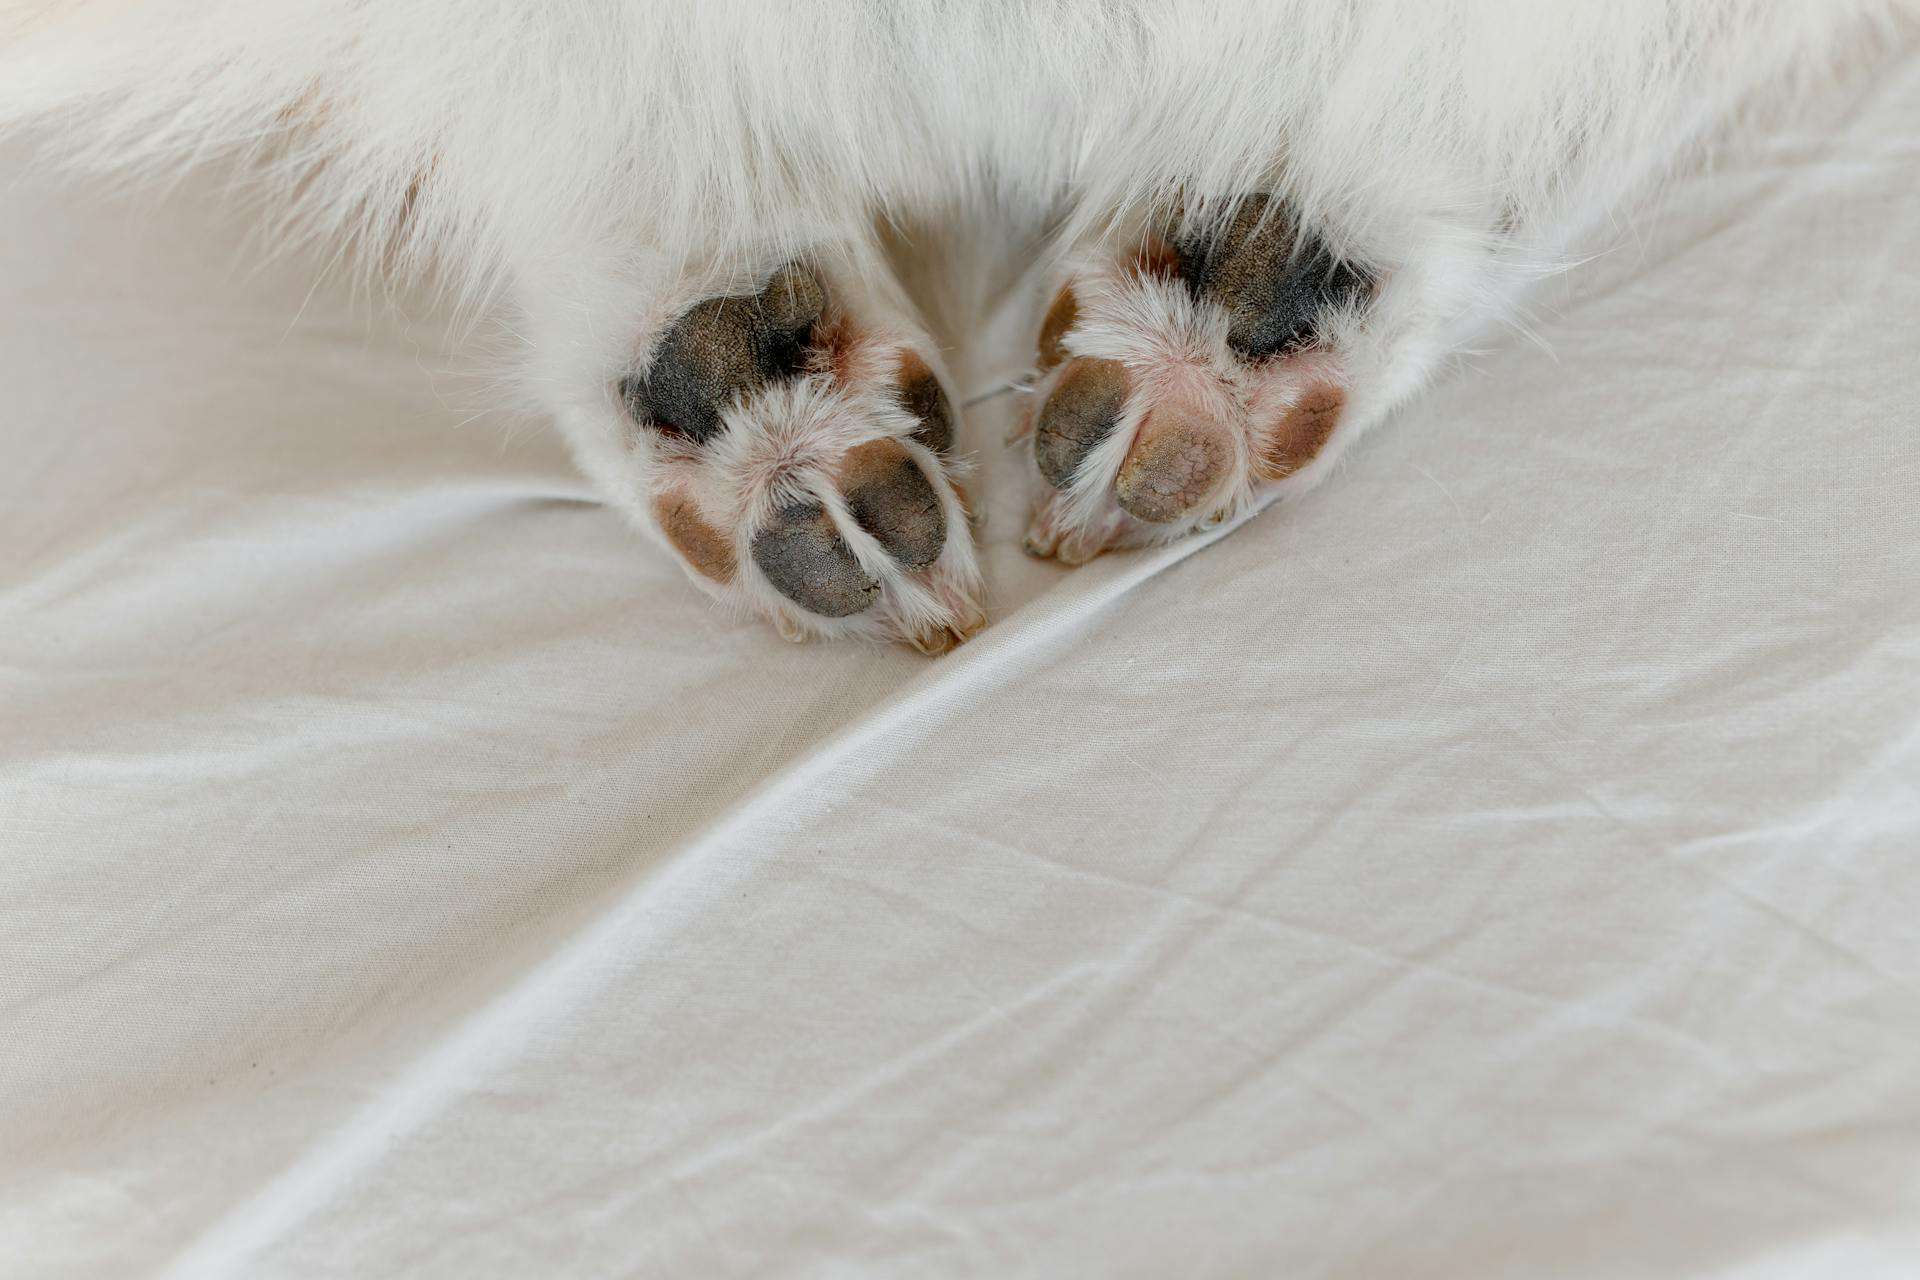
xmin=1173 ymin=196 xmax=1373 ymax=359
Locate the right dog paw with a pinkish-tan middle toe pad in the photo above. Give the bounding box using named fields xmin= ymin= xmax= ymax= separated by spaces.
xmin=1016 ymin=196 xmax=1375 ymax=564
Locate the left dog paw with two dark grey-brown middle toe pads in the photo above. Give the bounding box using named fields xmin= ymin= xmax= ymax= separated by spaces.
xmin=616 ymin=263 xmax=985 ymax=654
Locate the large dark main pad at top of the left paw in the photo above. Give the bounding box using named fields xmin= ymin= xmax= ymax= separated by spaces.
xmin=620 ymin=265 xmax=826 ymax=443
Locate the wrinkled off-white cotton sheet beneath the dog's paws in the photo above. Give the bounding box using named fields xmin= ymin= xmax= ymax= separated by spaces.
xmin=11 ymin=52 xmax=1920 ymax=1280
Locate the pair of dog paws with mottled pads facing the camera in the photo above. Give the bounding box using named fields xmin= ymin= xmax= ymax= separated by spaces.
xmin=616 ymin=196 xmax=1377 ymax=654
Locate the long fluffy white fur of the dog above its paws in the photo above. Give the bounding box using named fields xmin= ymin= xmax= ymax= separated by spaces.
xmin=0 ymin=0 xmax=1916 ymax=629
